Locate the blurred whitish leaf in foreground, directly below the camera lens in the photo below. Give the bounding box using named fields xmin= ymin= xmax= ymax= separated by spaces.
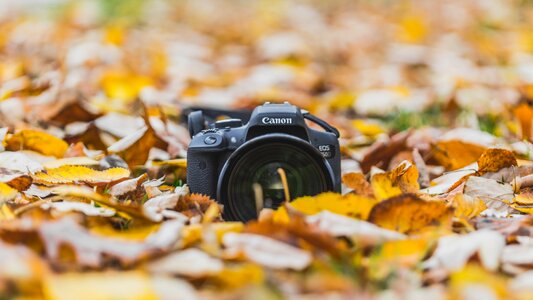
xmin=222 ymin=232 xmax=312 ymax=271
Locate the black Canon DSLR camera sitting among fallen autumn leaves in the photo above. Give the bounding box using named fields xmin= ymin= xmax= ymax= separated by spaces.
xmin=187 ymin=102 xmax=341 ymax=221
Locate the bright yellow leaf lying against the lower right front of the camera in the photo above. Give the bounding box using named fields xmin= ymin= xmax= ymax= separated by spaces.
xmin=273 ymin=192 xmax=377 ymax=223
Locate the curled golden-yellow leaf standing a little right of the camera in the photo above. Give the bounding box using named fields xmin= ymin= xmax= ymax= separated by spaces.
xmin=371 ymin=161 xmax=420 ymax=200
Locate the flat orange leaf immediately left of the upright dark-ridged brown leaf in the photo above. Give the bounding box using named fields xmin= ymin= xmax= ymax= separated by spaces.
xmin=433 ymin=140 xmax=485 ymax=170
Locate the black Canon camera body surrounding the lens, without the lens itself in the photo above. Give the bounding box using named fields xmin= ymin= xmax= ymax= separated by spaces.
xmin=187 ymin=102 xmax=341 ymax=219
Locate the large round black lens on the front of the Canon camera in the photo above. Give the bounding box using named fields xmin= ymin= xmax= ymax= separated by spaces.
xmin=219 ymin=136 xmax=332 ymax=221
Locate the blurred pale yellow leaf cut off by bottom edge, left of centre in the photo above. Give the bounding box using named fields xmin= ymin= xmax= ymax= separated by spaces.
xmin=44 ymin=271 xmax=158 ymax=300
